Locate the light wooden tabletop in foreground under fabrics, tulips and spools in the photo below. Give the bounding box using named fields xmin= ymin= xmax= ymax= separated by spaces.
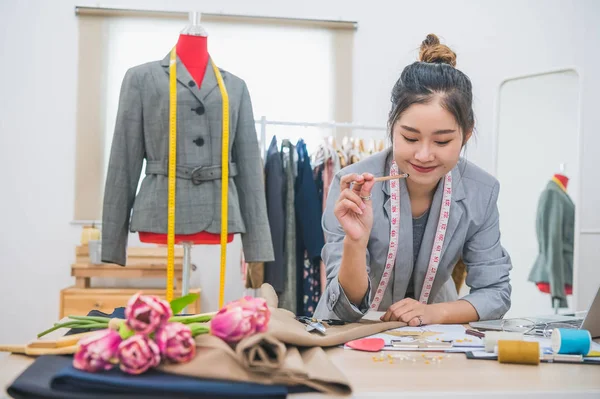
xmin=0 ymin=348 xmax=600 ymax=399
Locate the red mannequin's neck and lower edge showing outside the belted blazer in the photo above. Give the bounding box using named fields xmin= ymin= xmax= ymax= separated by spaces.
xmin=139 ymin=13 xmax=233 ymax=245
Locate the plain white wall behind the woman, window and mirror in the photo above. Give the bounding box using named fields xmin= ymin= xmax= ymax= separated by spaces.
xmin=0 ymin=0 xmax=600 ymax=342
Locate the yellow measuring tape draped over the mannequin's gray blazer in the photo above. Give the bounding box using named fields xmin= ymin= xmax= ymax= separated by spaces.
xmin=167 ymin=47 xmax=229 ymax=308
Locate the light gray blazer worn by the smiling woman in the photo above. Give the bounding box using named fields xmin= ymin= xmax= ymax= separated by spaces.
xmin=315 ymin=149 xmax=512 ymax=321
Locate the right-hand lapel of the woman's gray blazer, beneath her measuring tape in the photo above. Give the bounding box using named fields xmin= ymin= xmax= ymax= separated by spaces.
xmin=411 ymin=163 xmax=465 ymax=302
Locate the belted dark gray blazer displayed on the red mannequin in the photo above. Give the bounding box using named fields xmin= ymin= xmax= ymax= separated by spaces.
xmin=102 ymin=54 xmax=273 ymax=265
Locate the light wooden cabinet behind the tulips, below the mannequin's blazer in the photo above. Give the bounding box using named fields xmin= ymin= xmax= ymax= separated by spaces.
xmin=59 ymin=245 xmax=201 ymax=319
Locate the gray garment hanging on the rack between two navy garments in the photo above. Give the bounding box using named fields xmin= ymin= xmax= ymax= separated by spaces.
xmin=279 ymin=140 xmax=298 ymax=314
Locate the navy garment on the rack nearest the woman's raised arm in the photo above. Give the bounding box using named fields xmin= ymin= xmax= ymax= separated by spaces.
xmin=295 ymin=140 xmax=325 ymax=316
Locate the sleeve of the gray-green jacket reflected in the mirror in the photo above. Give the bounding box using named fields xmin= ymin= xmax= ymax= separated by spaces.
xmin=539 ymin=190 xmax=568 ymax=307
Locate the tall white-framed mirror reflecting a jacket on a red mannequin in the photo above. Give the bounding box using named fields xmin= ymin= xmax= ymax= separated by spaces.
xmin=496 ymin=69 xmax=580 ymax=317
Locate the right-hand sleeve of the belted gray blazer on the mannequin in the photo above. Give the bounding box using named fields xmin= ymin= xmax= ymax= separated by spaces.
xmin=232 ymin=83 xmax=275 ymax=262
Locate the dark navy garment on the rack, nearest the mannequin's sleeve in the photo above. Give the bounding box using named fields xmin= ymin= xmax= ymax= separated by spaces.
xmin=264 ymin=137 xmax=285 ymax=294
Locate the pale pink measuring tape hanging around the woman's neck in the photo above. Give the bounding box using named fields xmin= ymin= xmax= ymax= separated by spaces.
xmin=371 ymin=161 xmax=452 ymax=310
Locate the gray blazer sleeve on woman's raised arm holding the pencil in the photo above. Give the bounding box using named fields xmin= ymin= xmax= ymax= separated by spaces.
xmin=315 ymin=173 xmax=371 ymax=322
